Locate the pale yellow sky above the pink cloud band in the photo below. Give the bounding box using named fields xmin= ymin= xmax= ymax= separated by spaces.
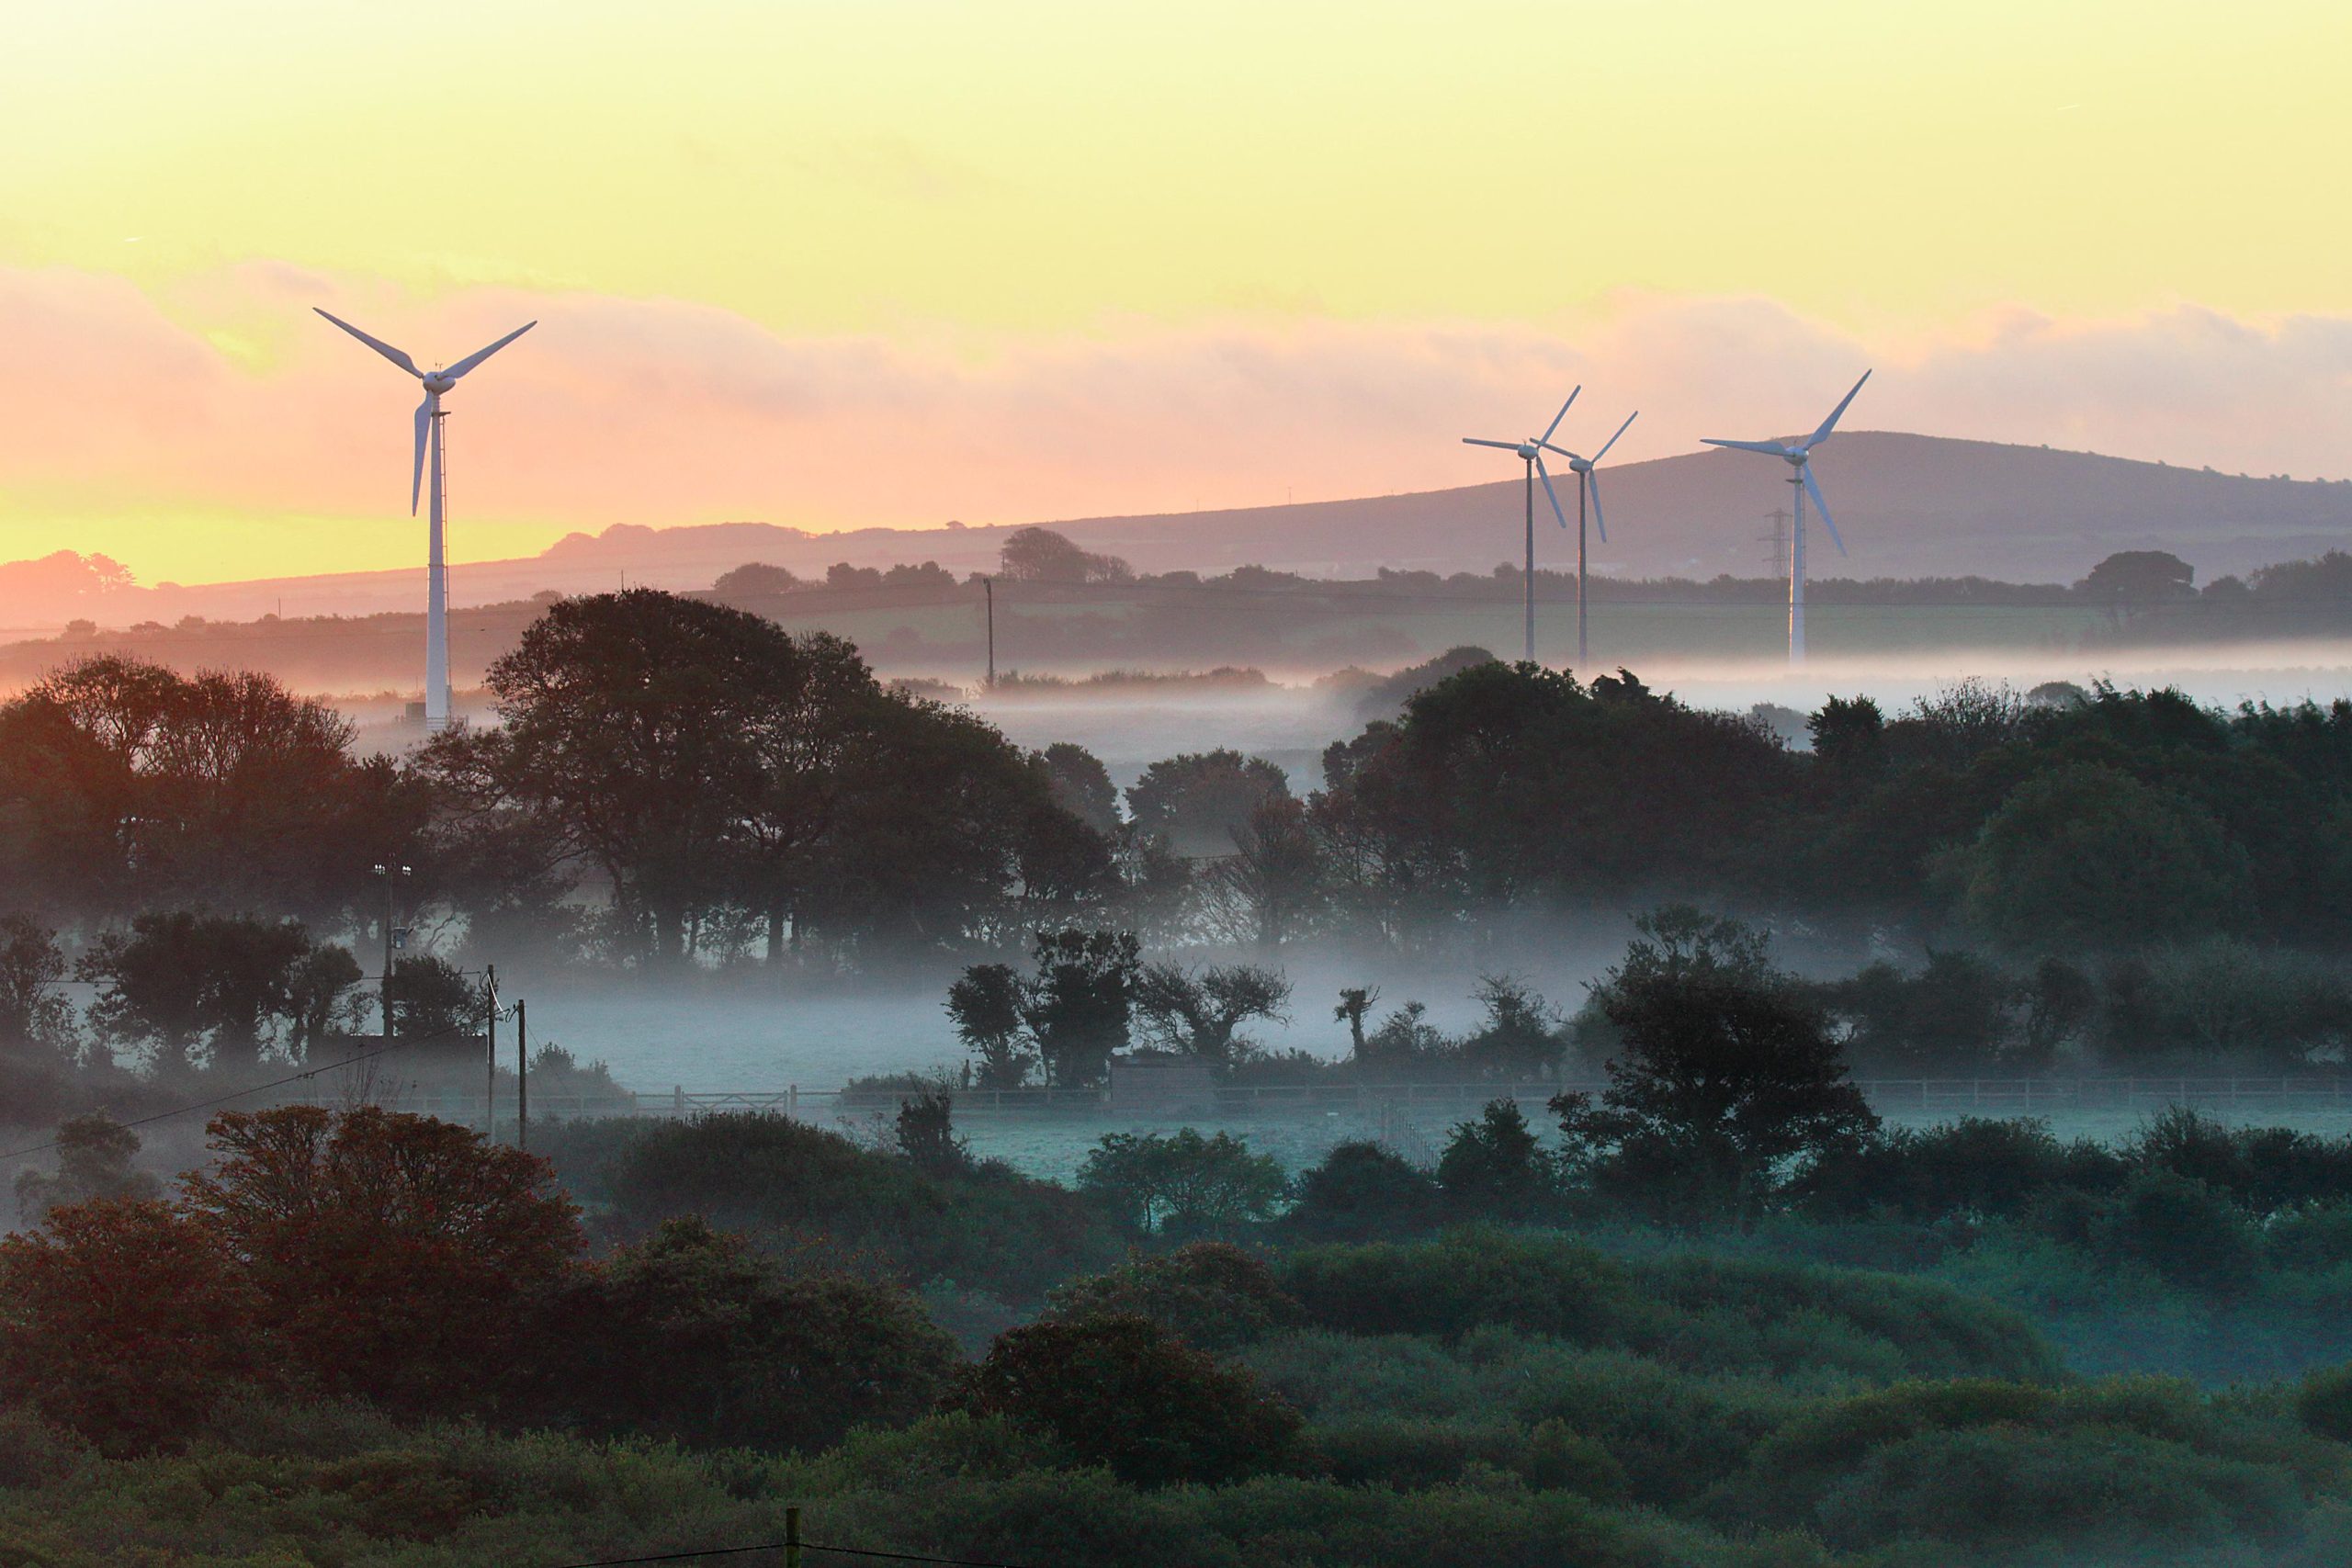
xmin=0 ymin=0 xmax=2352 ymax=576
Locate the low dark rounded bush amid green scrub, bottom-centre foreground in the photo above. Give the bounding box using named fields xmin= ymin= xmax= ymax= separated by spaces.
xmin=962 ymin=1314 xmax=1303 ymax=1485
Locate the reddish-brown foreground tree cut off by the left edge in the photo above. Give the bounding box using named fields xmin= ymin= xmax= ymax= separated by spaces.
xmin=0 ymin=1199 xmax=273 ymax=1455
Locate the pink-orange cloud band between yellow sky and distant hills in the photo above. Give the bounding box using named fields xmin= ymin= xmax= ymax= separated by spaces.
xmin=0 ymin=264 xmax=2352 ymax=581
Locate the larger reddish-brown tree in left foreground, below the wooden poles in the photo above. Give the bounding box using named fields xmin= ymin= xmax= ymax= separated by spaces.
xmin=181 ymin=1105 xmax=581 ymax=1413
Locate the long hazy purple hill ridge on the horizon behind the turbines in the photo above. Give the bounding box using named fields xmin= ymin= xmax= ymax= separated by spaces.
xmin=18 ymin=430 xmax=2352 ymax=627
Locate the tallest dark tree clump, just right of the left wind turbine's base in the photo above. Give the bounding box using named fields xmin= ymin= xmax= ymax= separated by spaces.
xmin=421 ymin=590 xmax=1108 ymax=959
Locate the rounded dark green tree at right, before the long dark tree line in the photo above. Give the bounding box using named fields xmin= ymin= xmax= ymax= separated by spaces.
xmin=1950 ymin=761 xmax=2251 ymax=950
